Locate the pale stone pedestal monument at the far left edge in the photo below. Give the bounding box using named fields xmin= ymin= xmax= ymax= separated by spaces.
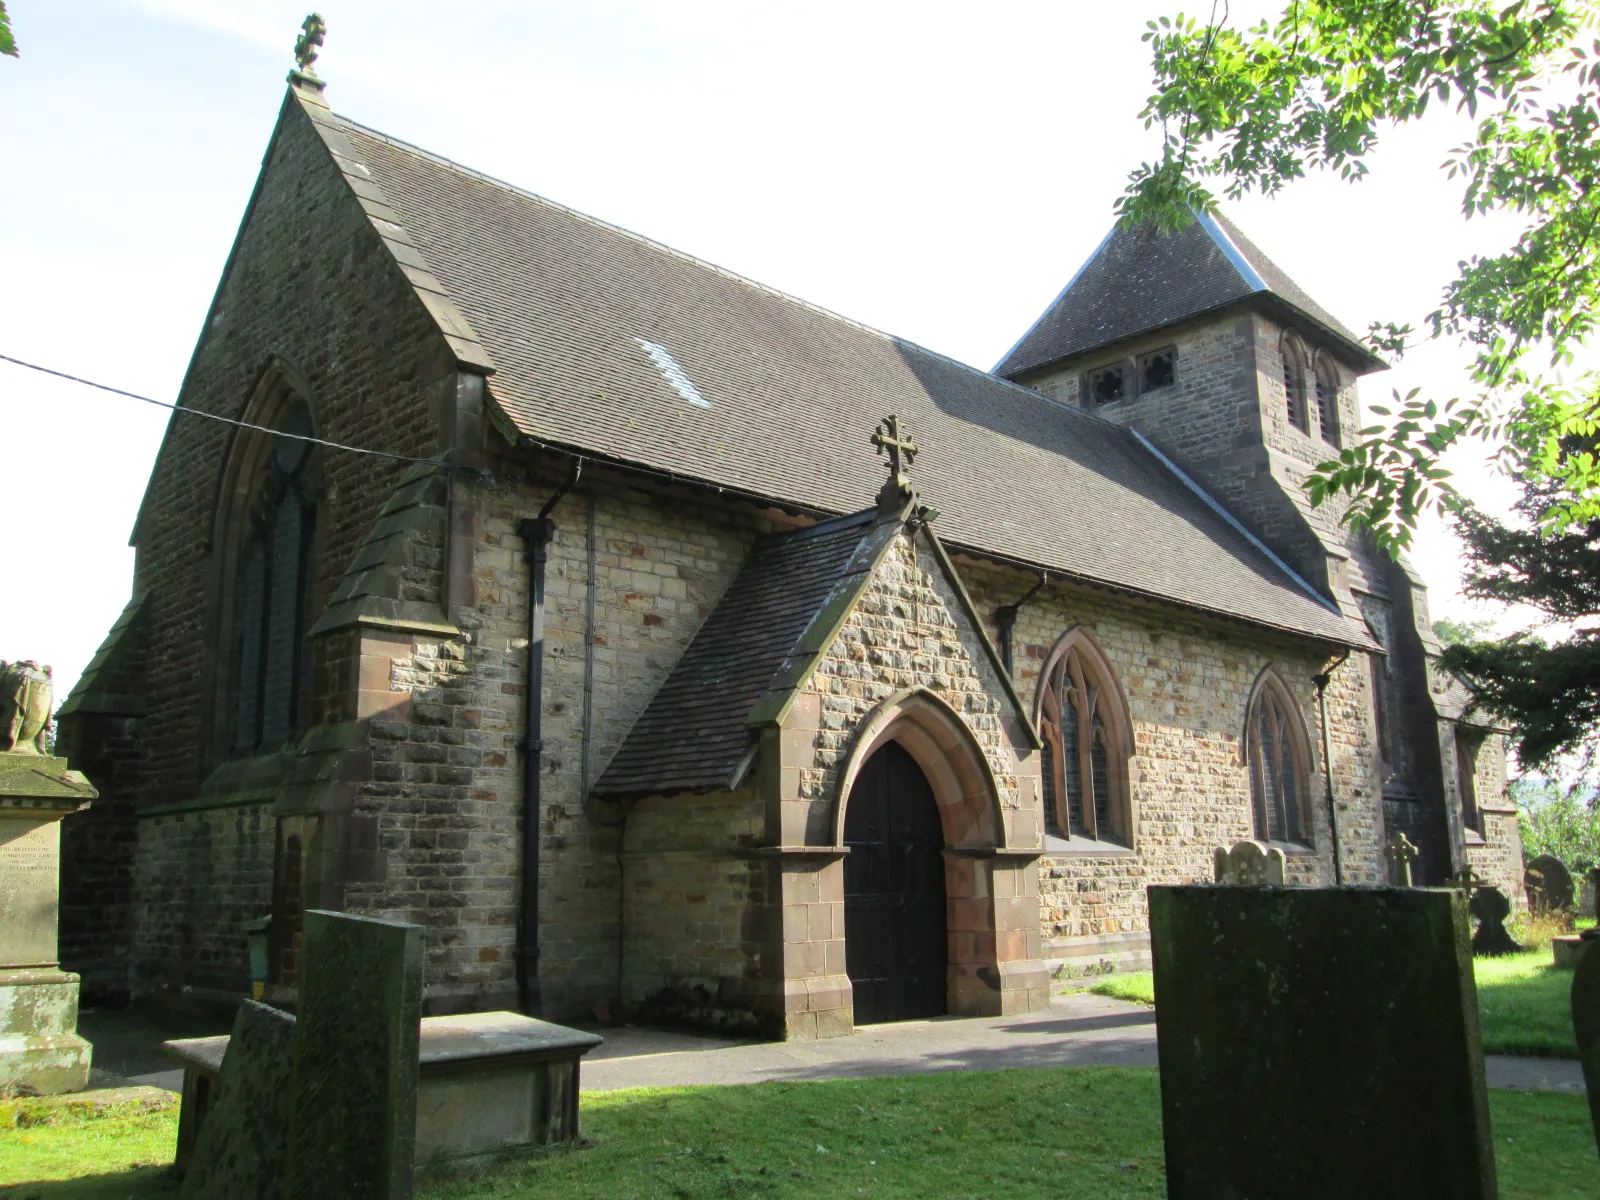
xmin=0 ymin=662 xmax=94 ymax=1094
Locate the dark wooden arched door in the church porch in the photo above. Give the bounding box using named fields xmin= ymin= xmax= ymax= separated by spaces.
xmin=845 ymin=742 xmax=946 ymax=1026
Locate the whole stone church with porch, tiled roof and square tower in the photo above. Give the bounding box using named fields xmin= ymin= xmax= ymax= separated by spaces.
xmin=59 ymin=51 xmax=1522 ymax=1038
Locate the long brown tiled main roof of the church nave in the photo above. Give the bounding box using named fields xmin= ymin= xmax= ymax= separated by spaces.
xmin=312 ymin=98 xmax=1365 ymax=643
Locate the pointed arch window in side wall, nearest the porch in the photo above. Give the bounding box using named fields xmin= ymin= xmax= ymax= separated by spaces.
xmin=1038 ymin=630 xmax=1133 ymax=846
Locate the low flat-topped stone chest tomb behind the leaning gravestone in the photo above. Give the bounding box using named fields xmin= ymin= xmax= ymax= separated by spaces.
xmin=165 ymin=1013 xmax=605 ymax=1174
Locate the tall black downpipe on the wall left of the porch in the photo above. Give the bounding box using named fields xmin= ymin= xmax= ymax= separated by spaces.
xmin=517 ymin=459 xmax=584 ymax=1016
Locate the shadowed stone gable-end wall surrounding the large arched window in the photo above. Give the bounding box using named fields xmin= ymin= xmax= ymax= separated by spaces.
xmin=80 ymin=102 xmax=467 ymax=992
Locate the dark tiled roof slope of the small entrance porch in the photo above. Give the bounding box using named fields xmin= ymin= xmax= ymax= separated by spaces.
xmin=595 ymin=512 xmax=901 ymax=797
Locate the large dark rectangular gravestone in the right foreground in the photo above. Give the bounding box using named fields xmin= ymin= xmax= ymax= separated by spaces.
xmin=1149 ymin=886 xmax=1496 ymax=1200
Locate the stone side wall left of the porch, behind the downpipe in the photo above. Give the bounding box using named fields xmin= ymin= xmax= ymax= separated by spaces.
xmin=395 ymin=464 xmax=766 ymax=1019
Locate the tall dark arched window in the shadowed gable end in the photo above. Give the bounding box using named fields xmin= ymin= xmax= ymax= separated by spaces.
xmin=230 ymin=402 xmax=317 ymax=754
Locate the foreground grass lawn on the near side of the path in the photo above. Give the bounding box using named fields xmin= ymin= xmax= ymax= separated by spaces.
xmin=0 ymin=1067 xmax=1597 ymax=1200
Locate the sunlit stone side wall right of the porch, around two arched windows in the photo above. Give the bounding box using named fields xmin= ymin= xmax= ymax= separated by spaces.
xmin=960 ymin=558 xmax=1382 ymax=970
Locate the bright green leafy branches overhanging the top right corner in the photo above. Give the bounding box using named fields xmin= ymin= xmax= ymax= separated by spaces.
xmin=1118 ymin=0 xmax=1600 ymax=550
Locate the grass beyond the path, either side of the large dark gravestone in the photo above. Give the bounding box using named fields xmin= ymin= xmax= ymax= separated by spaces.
xmin=1088 ymin=949 xmax=1578 ymax=1058
